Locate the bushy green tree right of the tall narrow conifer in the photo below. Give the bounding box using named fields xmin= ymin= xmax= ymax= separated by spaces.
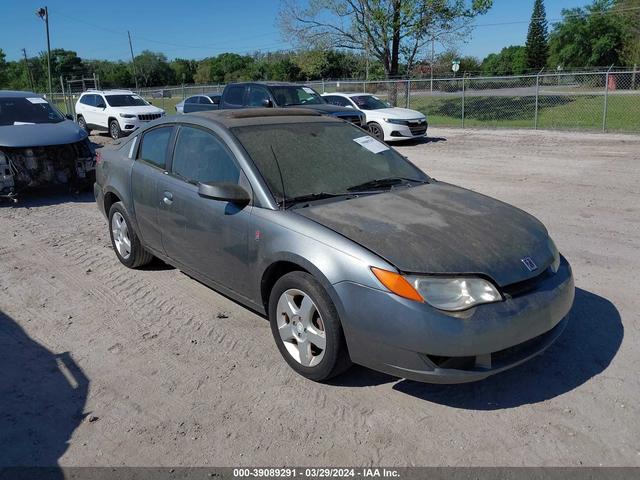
xmin=549 ymin=0 xmax=628 ymax=68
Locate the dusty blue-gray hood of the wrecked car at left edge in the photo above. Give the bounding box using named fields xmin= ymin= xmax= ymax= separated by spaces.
xmin=0 ymin=120 xmax=87 ymax=148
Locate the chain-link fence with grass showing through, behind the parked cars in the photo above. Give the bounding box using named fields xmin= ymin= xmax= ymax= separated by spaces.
xmin=53 ymin=69 xmax=640 ymax=133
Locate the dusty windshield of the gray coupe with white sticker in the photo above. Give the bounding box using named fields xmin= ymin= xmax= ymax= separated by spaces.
xmin=232 ymin=121 xmax=429 ymax=203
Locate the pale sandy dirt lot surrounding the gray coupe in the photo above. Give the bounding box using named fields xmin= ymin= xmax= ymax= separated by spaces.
xmin=0 ymin=129 xmax=640 ymax=466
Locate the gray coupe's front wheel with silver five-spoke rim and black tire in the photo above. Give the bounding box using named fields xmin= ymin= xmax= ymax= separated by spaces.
xmin=269 ymin=272 xmax=351 ymax=382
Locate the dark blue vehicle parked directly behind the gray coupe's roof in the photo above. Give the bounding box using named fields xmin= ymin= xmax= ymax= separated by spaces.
xmin=220 ymin=82 xmax=366 ymax=127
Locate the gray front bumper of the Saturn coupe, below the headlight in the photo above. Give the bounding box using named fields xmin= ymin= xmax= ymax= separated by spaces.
xmin=334 ymin=258 xmax=574 ymax=383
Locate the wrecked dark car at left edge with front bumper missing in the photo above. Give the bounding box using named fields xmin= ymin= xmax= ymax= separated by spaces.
xmin=0 ymin=90 xmax=95 ymax=199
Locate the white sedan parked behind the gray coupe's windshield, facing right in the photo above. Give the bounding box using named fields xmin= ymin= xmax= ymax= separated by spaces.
xmin=322 ymin=93 xmax=428 ymax=142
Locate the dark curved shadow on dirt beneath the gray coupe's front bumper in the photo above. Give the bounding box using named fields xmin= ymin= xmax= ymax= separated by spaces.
xmin=393 ymin=288 xmax=624 ymax=410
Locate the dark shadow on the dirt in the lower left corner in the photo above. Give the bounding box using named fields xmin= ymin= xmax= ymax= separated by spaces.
xmin=0 ymin=311 xmax=89 ymax=468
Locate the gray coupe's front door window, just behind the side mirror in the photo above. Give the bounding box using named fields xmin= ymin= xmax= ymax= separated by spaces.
xmin=173 ymin=127 xmax=240 ymax=183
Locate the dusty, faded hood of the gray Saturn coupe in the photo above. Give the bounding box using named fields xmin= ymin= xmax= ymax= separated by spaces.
xmin=293 ymin=181 xmax=553 ymax=286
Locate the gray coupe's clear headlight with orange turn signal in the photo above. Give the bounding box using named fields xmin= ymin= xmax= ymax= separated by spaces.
xmin=371 ymin=267 xmax=502 ymax=312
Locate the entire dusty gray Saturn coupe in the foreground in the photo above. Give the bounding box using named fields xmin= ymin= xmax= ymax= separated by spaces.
xmin=95 ymin=109 xmax=574 ymax=383
